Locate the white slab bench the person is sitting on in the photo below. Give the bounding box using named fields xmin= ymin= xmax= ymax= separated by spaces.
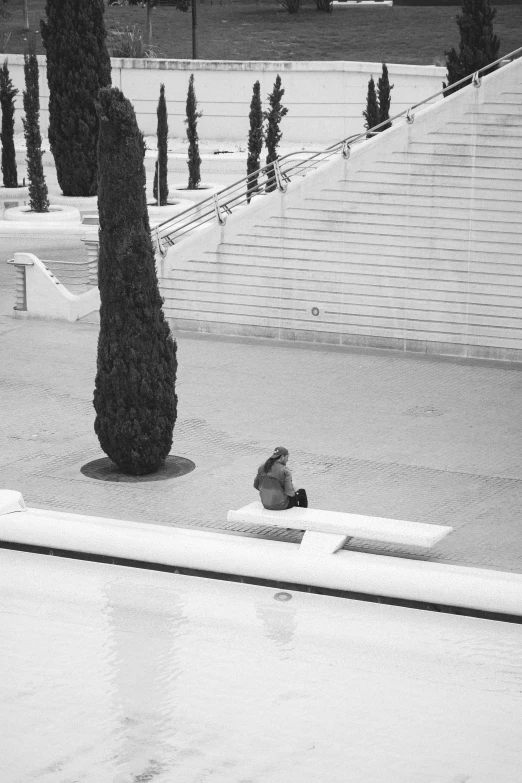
xmin=227 ymin=500 xmax=453 ymax=554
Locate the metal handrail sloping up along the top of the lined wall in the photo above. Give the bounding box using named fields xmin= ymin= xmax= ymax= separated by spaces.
xmin=151 ymin=47 xmax=522 ymax=255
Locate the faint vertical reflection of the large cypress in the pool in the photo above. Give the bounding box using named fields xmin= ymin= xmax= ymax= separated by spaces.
xmin=106 ymin=581 xmax=187 ymax=783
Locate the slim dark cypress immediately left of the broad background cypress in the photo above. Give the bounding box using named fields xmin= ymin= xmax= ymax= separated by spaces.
xmin=22 ymin=40 xmax=49 ymax=212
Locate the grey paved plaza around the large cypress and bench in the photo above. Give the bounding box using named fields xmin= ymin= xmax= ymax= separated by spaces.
xmin=0 ymin=165 xmax=522 ymax=572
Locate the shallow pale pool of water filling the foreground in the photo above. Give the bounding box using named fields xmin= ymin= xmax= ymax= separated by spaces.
xmin=0 ymin=550 xmax=522 ymax=783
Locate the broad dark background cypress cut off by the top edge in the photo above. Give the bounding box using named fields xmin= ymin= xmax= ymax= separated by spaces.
xmin=41 ymin=0 xmax=111 ymax=196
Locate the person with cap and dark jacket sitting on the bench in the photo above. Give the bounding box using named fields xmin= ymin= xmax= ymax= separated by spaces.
xmin=254 ymin=446 xmax=308 ymax=511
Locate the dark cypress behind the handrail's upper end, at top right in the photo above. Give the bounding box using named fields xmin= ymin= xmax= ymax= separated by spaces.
xmin=443 ymin=0 xmax=500 ymax=95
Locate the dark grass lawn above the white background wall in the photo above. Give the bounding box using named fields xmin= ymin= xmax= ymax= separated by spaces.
xmin=0 ymin=0 xmax=522 ymax=65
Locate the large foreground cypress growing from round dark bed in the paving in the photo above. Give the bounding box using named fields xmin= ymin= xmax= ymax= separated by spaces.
xmin=94 ymin=87 xmax=177 ymax=476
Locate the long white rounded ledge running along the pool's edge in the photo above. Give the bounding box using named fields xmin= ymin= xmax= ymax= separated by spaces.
xmin=0 ymin=508 xmax=522 ymax=616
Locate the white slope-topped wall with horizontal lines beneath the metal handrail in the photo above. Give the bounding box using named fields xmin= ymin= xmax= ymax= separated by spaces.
xmin=160 ymin=59 xmax=522 ymax=361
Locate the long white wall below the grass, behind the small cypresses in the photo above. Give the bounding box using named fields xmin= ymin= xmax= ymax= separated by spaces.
xmin=0 ymin=54 xmax=446 ymax=146
